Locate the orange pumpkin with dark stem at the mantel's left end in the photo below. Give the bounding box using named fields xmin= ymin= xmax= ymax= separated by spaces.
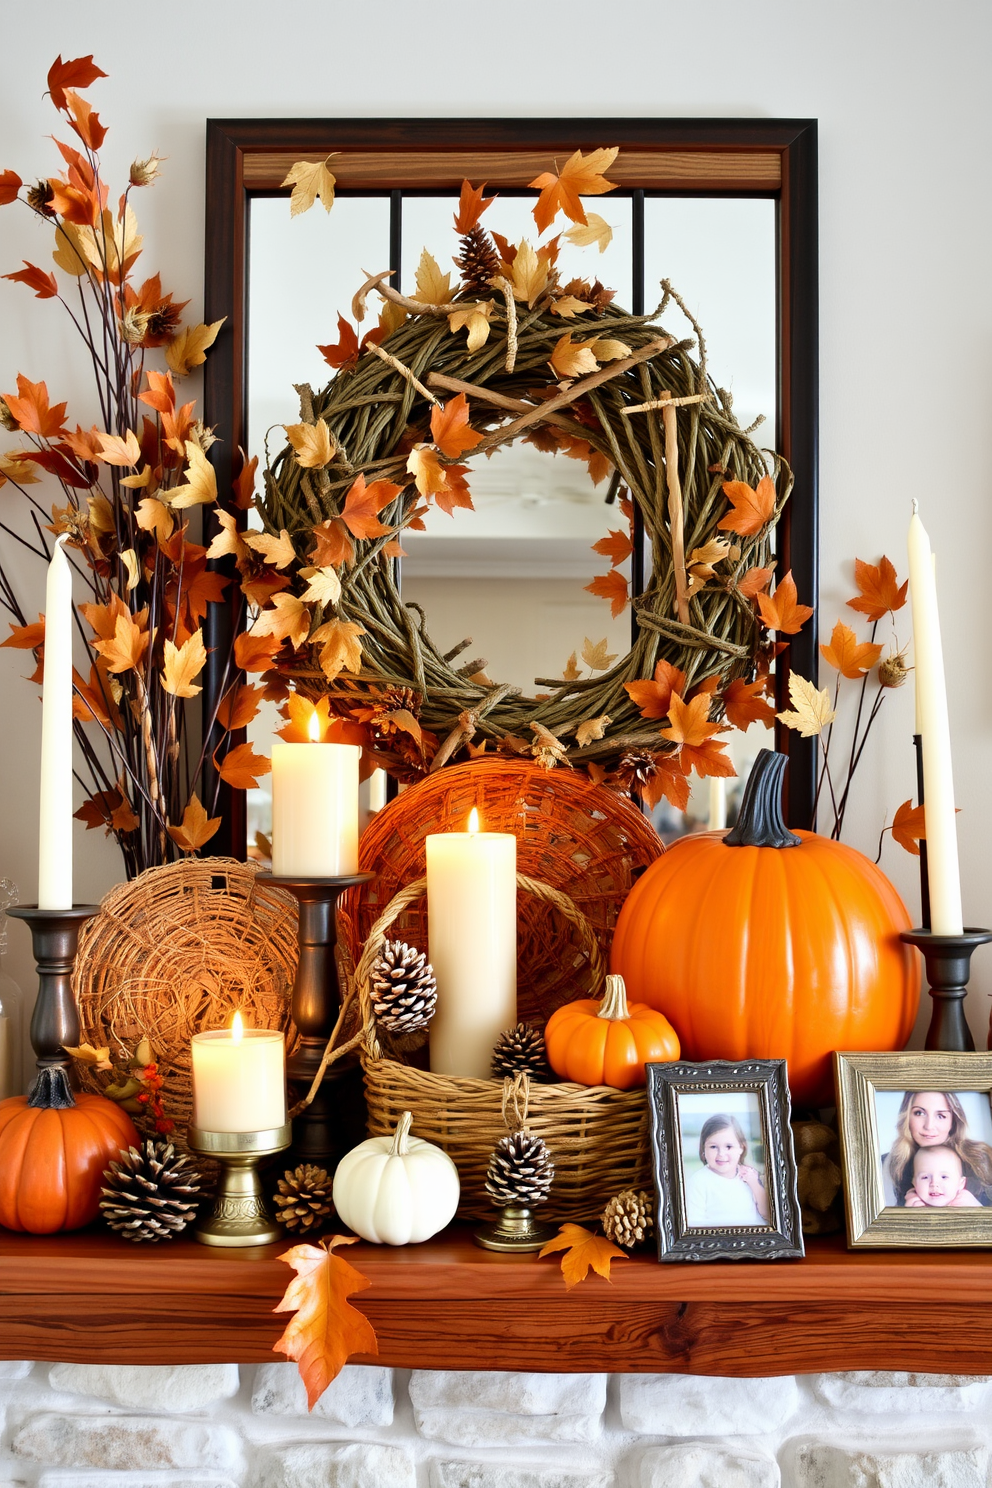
xmin=0 ymin=1068 xmax=140 ymax=1235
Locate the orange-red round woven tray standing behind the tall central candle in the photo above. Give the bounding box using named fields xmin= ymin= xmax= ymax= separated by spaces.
xmin=341 ymin=759 xmax=663 ymax=1022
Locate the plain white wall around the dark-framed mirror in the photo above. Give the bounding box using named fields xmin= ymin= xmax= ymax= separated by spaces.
xmin=0 ymin=0 xmax=992 ymax=1045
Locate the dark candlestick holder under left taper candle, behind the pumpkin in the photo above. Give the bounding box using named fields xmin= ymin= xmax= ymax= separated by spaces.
xmin=7 ymin=905 xmax=100 ymax=1088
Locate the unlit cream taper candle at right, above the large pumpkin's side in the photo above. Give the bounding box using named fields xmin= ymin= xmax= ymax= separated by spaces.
xmin=909 ymin=501 xmax=962 ymax=934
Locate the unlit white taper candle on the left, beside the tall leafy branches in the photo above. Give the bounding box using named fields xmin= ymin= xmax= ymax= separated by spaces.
xmin=37 ymin=537 xmax=73 ymax=909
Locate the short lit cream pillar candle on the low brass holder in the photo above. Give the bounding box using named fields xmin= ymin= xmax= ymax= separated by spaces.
xmin=193 ymin=1013 xmax=286 ymax=1132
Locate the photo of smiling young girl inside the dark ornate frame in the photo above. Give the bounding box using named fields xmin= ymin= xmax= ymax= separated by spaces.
xmin=678 ymin=1091 xmax=769 ymax=1229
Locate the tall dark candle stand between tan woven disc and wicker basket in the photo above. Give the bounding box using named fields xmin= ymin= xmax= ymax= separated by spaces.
xmin=266 ymin=873 xmax=375 ymax=1173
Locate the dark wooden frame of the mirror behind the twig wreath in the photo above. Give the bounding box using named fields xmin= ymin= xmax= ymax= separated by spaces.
xmin=204 ymin=119 xmax=818 ymax=857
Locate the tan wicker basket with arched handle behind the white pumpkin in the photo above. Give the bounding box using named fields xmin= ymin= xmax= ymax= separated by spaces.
xmin=355 ymin=873 xmax=650 ymax=1222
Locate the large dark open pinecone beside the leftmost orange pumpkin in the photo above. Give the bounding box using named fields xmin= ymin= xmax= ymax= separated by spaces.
xmin=100 ymin=1138 xmax=199 ymax=1240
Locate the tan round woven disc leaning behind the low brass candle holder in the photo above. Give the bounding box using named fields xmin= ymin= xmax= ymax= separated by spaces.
xmin=73 ymin=857 xmax=297 ymax=1144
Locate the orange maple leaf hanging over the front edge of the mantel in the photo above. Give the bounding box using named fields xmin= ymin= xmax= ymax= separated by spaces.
xmin=272 ymin=1235 xmax=379 ymax=1411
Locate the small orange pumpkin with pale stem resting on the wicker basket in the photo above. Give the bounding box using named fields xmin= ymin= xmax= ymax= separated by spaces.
xmin=544 ymin=976 xmax=680 ymax=1091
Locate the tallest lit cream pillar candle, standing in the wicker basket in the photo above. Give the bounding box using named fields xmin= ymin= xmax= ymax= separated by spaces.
xmin=427 ymin=811 xmax=516 ymax=1080
